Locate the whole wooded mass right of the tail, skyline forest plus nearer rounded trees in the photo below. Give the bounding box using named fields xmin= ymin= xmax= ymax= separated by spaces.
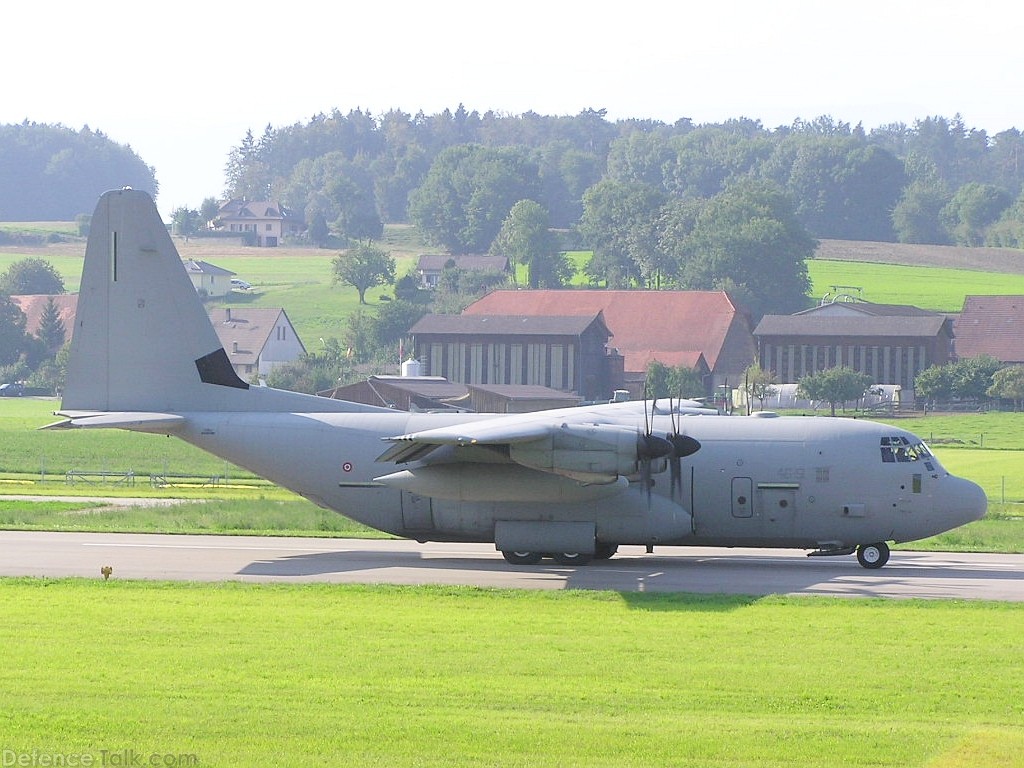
xmin=214 ymin=105 xmax=1024 ymax=317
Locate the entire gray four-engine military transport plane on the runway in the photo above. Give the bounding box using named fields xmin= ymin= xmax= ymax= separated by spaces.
xmin=46 ymin=188 xmax=986 ymax=568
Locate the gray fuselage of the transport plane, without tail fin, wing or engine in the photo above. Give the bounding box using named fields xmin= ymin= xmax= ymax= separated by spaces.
xmin=167 ymin=413 xmax=985 ymax=561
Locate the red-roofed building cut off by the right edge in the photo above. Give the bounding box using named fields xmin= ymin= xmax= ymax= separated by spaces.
xmin=953 ymin=296 xmax=1024 ymax=364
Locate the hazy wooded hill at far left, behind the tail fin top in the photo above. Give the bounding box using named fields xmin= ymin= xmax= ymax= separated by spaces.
xmin=0 ymin=121 xmax=157 ymax=221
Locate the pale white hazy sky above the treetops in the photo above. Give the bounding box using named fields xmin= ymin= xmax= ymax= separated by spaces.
xmin=0 ymin=0 xmax=1024 ymax=216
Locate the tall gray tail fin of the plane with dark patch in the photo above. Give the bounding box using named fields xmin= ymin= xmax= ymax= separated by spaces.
xmin=61 ymin=188 xmax=379 ymax=413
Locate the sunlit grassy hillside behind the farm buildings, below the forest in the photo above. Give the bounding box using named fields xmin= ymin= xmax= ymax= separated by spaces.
xmin=6 ymin=224 xmax=1024 ymax=346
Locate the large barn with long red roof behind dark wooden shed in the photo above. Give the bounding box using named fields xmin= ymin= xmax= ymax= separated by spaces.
xmin=464 ymin=290 xmax=757 ymax=392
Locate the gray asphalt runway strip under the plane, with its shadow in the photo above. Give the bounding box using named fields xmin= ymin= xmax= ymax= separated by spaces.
xmin=0 ymin=530 xmax=1024 ymax=602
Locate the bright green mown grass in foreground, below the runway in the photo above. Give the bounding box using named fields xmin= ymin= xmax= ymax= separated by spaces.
xmin=0 ymin=580 xmax=1024 ymax=768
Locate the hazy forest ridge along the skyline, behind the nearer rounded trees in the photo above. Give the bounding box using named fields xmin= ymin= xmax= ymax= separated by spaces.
xmin=225 ymin=105 xmax=1024 ymax=252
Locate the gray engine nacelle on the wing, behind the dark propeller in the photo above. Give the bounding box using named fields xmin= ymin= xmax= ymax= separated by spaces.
xmin=509 ymin=424 xmax=672 ymax=483
